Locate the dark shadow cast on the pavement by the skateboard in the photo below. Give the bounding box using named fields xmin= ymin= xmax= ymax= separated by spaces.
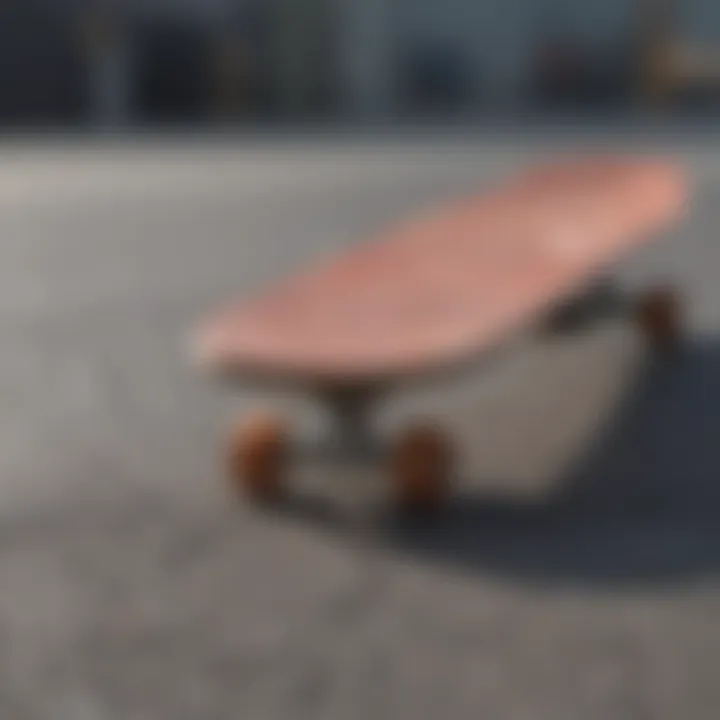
xmin=387 ymin=343 xmax=720 ymax=585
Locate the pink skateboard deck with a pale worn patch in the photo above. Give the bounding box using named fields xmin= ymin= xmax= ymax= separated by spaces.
xmin=195 ymin=160 xmax=686 ymax=381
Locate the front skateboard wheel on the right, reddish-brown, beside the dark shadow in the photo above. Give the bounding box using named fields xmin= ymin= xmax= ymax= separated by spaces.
xmin=390 ymin=425 xmax=453 ymax=513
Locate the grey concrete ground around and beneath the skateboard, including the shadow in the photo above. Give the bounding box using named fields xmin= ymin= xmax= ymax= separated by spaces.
xmin=0 ymin=131 xmax=720 ymax=720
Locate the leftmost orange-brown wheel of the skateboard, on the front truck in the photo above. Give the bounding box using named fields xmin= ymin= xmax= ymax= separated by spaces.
xmin=228 ymin=415 xmax=289 ymax=503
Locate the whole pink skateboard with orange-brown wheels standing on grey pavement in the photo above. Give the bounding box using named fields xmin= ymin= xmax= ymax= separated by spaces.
xmin=195 ymin=158 xmax=688 ymax=511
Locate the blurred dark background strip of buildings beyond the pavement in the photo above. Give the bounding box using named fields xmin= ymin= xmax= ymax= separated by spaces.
xmin=0 ymin=0 xmax=720 ymax=127
